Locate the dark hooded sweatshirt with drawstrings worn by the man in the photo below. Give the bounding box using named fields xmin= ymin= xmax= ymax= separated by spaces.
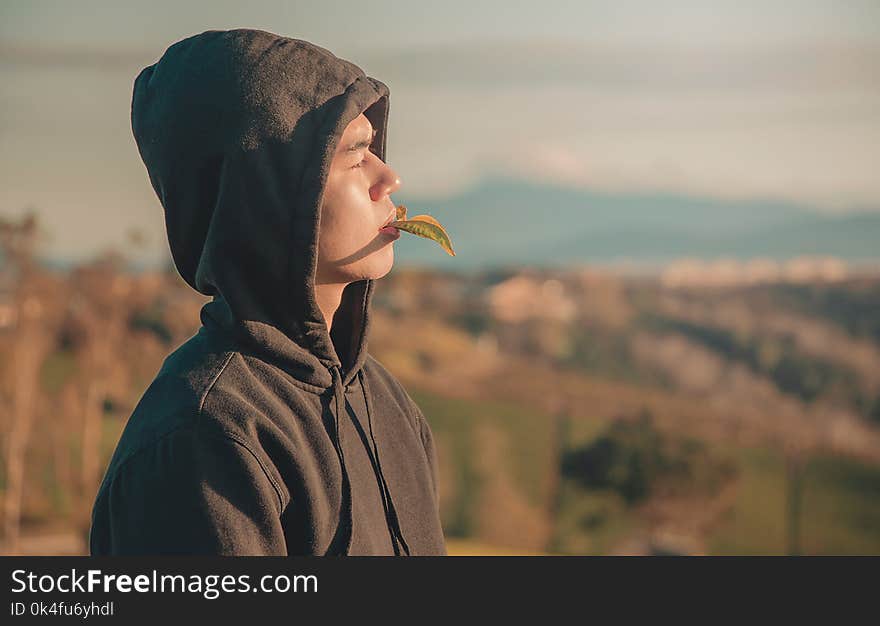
xmin=90 ymin=29 xmax=446 ymax=555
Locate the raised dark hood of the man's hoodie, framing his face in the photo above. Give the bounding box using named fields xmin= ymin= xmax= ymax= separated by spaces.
xmin=131 ymin=29 xmax=389 ymax=389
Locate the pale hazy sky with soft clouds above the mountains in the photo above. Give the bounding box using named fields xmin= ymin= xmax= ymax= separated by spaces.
xmin=0 ymin=0 xmax=880 ymax=258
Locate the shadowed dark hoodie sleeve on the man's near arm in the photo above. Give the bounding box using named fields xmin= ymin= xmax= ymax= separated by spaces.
xmin=89 ymin=422 xmax=287 ymax=556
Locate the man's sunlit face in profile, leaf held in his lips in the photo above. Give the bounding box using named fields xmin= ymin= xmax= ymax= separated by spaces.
xmin=315 ymin=113 xmax=400 ymax=284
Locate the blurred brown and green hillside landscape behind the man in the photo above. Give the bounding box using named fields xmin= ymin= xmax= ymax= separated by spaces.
xmin=0 ymin=212 xmax=880 ymax=554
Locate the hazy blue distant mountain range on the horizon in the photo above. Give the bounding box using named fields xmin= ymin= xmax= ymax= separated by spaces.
xmin=395 ymin=177 xmax=880 ymax=269
